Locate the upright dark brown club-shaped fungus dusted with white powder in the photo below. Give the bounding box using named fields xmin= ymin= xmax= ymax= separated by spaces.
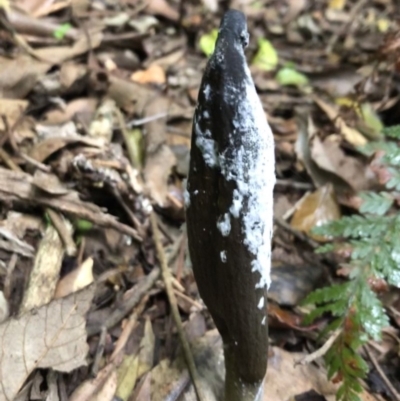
xmin=186 ymin=10 xmax=275 ymax=401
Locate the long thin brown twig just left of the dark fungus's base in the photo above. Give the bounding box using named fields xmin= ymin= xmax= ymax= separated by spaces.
xmin=150 ymin=212 xmax=205 ymax=401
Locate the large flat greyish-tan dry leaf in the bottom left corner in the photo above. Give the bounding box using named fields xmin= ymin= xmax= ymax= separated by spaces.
xmin=0 ymin=286 xmax=94 ymax=401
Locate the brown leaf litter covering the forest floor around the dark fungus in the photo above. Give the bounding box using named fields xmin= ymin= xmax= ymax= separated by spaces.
xmin=0 ymin=0 xmax=400 ymax=400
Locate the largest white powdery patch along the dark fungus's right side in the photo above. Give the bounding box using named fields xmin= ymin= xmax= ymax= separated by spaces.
xmin=219 ymin=65 xmax=275 ymax=288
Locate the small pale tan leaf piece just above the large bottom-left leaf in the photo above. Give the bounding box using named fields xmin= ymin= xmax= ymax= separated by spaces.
xmin=54 ymin=258 xmax=93 ymax=298
